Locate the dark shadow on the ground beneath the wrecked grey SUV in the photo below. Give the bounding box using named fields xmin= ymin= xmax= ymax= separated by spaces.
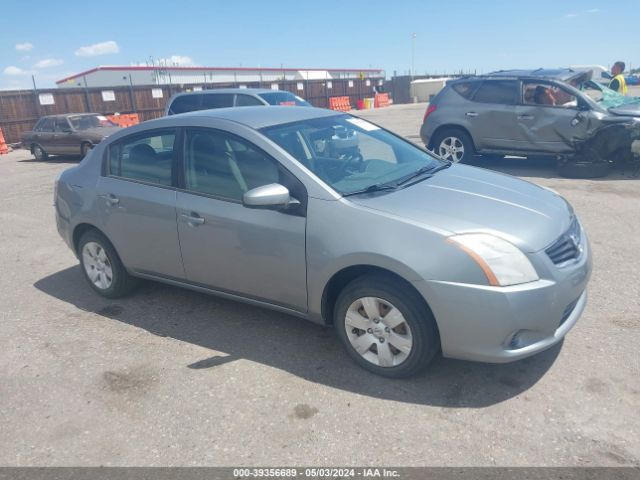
xmin=464 ymin=155 xmax=639 ymax=181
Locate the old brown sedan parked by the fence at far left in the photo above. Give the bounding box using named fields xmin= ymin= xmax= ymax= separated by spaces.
xmin=22 ymin=113 xmax=121 ymax=160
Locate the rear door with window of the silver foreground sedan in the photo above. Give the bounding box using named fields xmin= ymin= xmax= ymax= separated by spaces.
xmin=97 ymin=129 xmax=184 ymax=279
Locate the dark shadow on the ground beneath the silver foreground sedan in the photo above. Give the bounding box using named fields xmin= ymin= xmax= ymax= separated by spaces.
xmin=34 ymin=266 xmax=561 ymax=408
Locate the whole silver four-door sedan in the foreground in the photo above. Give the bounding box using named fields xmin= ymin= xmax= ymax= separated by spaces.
xmin=55 ymin=107 xmax=591 ymax=377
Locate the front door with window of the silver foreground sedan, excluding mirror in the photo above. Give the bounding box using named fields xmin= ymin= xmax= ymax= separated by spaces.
xmin=177 ymin=128 xmax=307 ymax=312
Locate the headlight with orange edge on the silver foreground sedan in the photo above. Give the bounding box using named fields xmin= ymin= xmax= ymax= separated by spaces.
xmin=448 ymin=233 xmax=538 ymax=287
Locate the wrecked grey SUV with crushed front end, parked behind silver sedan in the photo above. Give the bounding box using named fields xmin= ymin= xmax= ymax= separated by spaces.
xmin=420 ymin=69 xmax=640 ymax=177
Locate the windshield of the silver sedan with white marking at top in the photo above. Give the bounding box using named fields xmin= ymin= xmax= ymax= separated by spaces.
xmin=261 ymin=114 xmax=449 ymax=195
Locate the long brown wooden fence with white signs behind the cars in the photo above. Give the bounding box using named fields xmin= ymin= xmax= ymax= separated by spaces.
xmin=0 ymin=78 xmax=383 ymax=143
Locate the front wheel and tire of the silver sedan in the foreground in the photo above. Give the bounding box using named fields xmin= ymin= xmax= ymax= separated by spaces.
xmin=334 ymin=275 xmax=439 ymax=378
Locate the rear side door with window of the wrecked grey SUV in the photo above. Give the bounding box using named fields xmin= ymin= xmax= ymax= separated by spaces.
xmin=464 ymin=79 xmax=527 ymax=152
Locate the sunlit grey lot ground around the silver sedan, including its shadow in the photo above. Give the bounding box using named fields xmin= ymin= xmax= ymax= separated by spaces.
xmin=0 ymin=105 xmax=640 ymax=466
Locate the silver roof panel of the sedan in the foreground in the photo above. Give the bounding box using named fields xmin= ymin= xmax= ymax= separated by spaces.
xmin=178 ymin=105 xmax=343 ymax=130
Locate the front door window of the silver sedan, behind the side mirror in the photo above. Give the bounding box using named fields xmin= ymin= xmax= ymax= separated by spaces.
xmin=184 ymin=130 xmax=280 ymax=201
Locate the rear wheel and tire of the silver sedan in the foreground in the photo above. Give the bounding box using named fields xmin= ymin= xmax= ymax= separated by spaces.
xmin=78 ymin=230 xmax=135 ymax=298
